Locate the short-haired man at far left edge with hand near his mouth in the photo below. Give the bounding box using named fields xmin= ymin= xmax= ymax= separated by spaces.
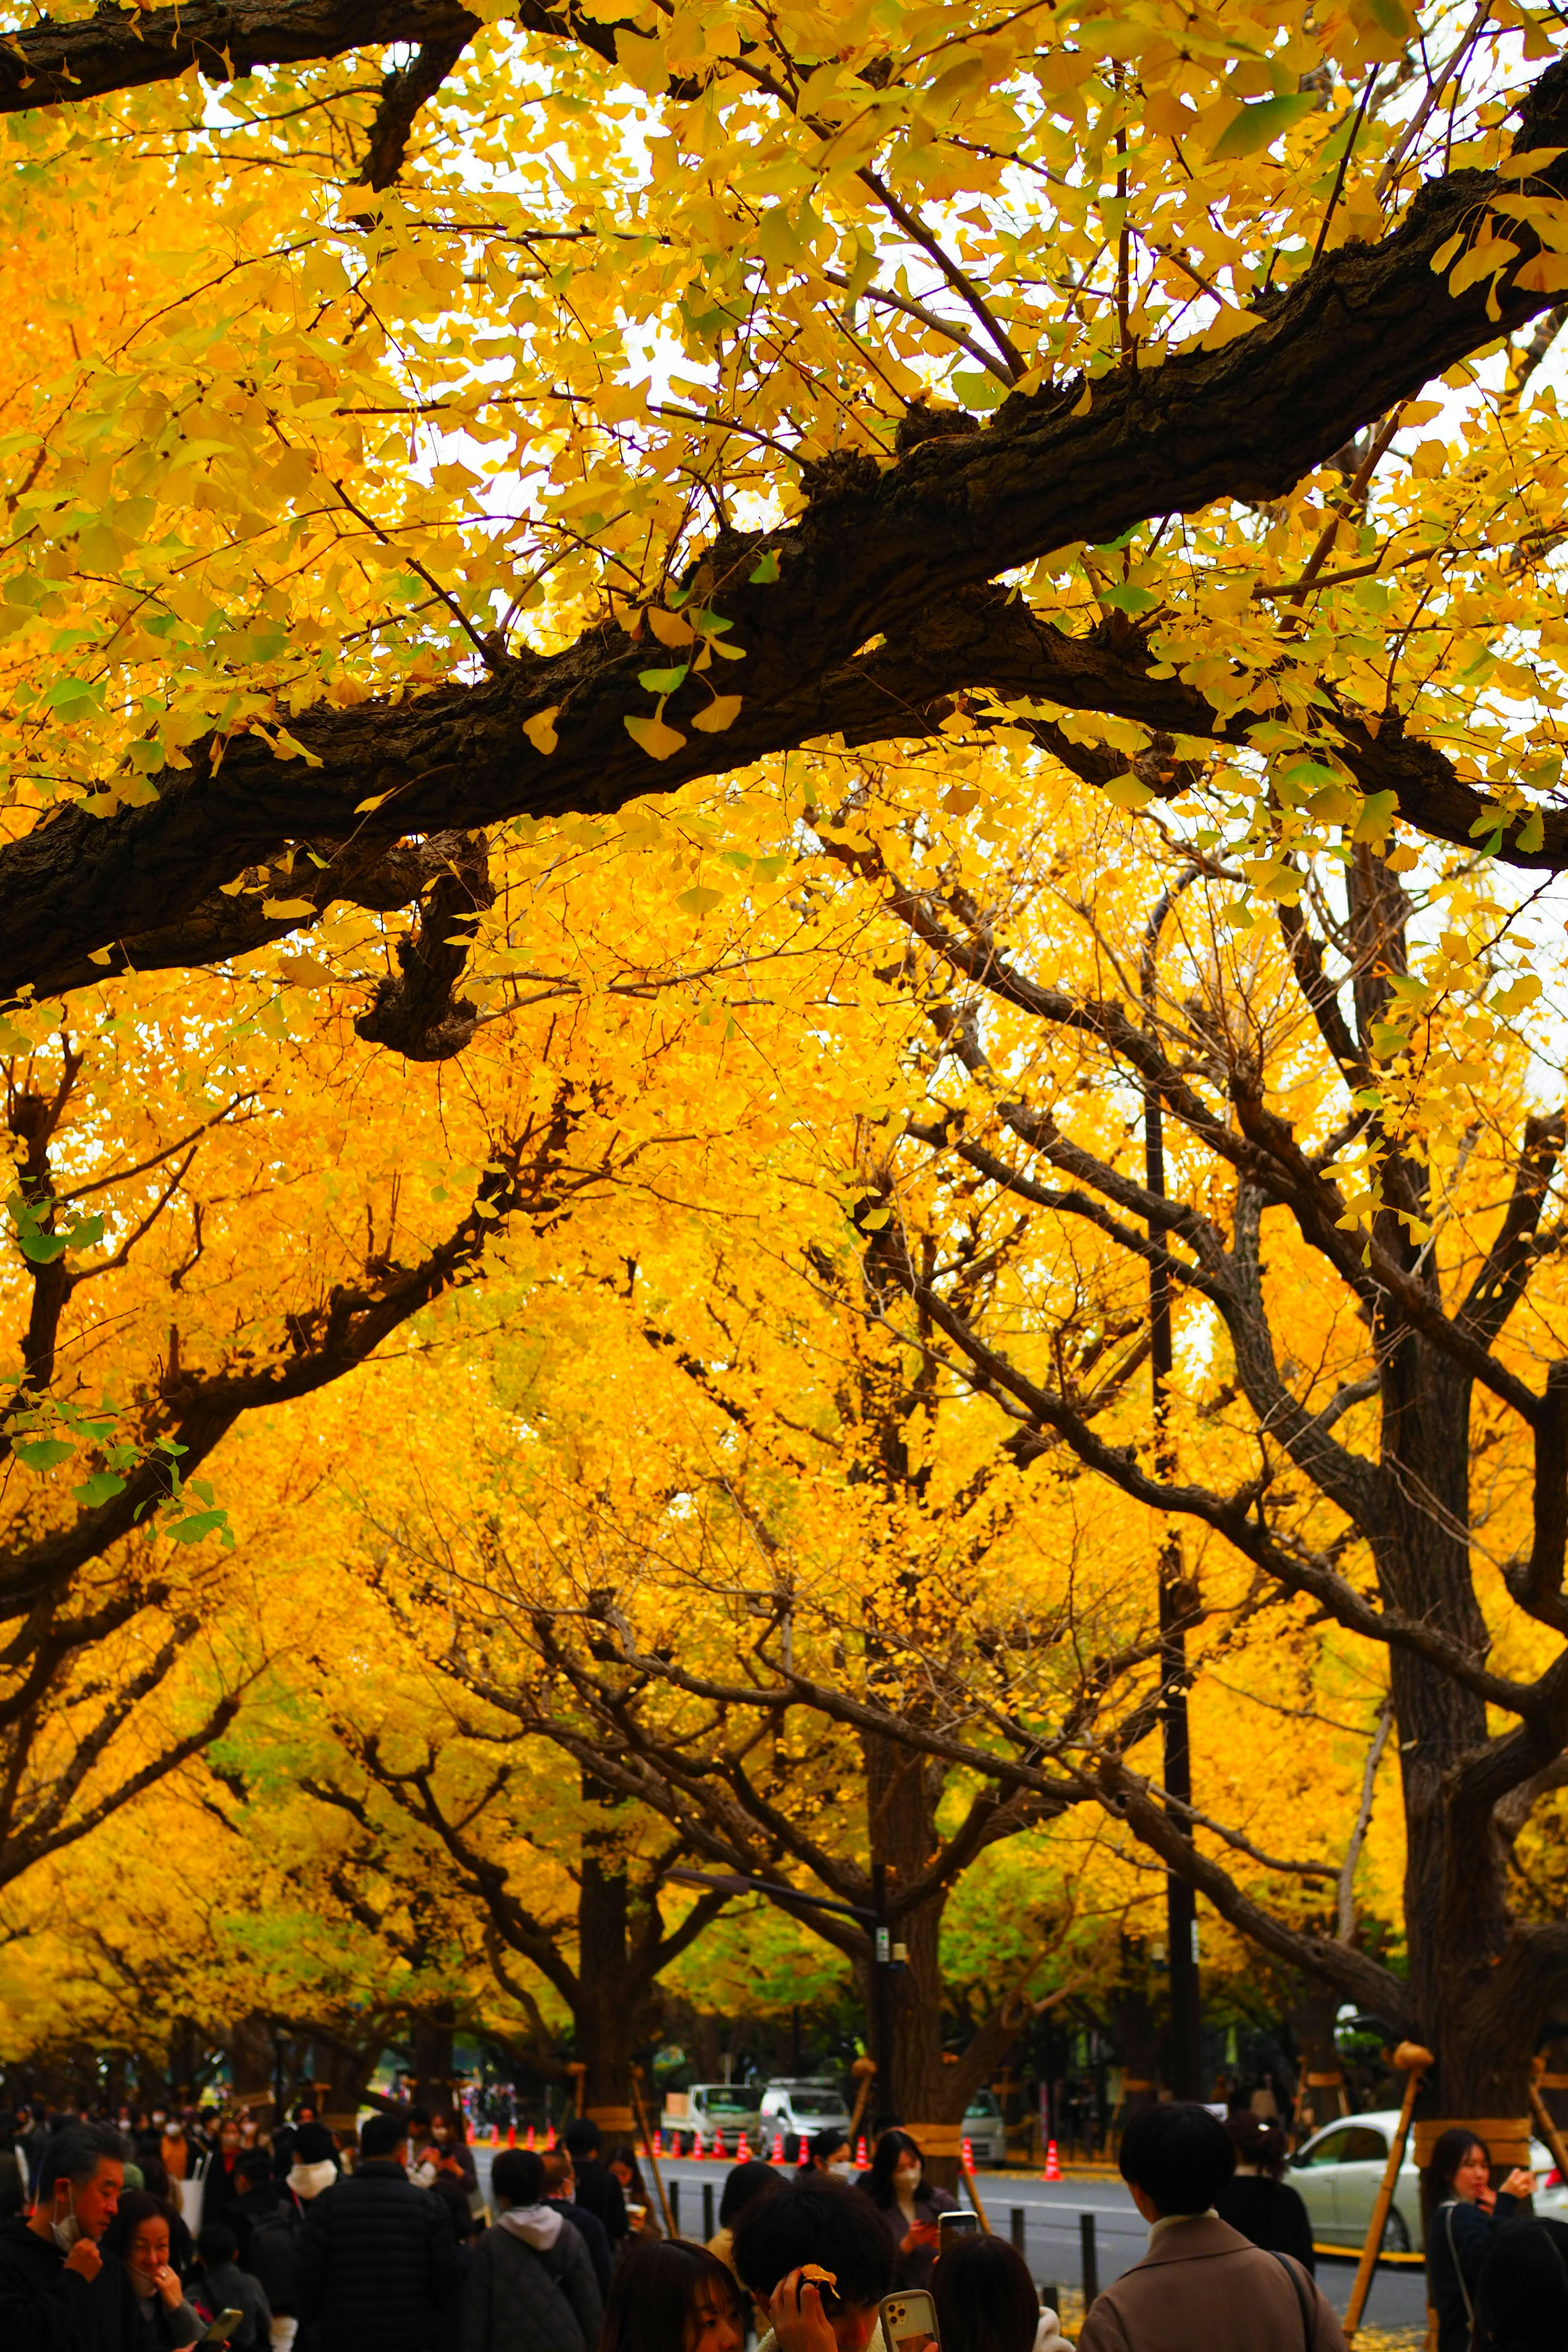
xmin=0 ymin=2124 xmax=141 ymax=2352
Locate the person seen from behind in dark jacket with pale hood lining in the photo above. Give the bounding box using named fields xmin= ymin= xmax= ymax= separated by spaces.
xmin=463 ymin=2147 xmax=604 ymax=2352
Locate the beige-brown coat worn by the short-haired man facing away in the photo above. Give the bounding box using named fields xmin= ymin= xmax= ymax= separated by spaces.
xmin=1079 ymin=2216 xmax=1345 ymax=2352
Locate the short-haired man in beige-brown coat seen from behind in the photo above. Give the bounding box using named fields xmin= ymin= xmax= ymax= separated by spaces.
xmin=1079 ymin=2100 xmax=1345 ymax=2352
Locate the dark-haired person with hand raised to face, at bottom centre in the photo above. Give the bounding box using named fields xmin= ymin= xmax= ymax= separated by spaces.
xmin=731 ymin=2173 xmax=893 ymax=2352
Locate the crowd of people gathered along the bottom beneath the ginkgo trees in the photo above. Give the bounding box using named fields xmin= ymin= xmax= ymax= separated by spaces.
xmin=0 ymin=2103 xmax=1568 ymax=2352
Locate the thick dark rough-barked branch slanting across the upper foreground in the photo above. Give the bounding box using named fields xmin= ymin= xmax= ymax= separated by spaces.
xmin=15 ymin=71 xmax=1568 ymax=995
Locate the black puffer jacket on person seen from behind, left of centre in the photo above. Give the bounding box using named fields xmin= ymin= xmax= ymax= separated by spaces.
xmin=294 ymin=2157 xmax=459 ymax=2352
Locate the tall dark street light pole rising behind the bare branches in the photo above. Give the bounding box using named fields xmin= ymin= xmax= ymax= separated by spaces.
xmin=1140 ymin=866 xmax=1204 ymax=2098
